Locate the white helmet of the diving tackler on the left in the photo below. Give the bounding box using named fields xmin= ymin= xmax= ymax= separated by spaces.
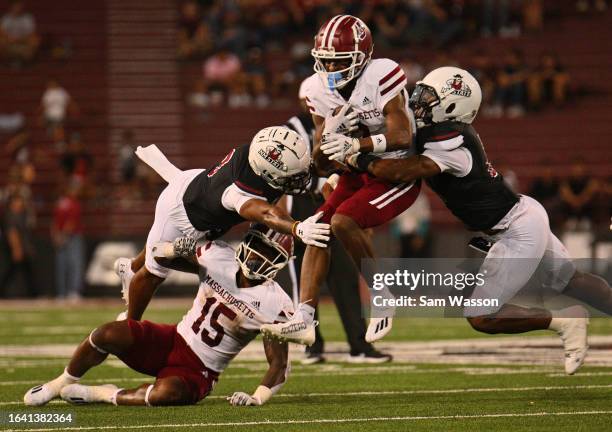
xmin=249 ymin=126 xmax=311 ymax=195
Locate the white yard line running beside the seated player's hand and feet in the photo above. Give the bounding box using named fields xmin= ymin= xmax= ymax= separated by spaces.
xmin=0 ymin=386 xmax=612 ymax=406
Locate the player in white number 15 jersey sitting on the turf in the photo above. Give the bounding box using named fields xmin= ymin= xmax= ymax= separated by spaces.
xmin=24 ymin=225 xmax=293 ymax=405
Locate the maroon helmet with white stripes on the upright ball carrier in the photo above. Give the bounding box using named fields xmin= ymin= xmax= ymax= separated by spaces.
xmin=310 ymin=15 xmax=374 ymax=89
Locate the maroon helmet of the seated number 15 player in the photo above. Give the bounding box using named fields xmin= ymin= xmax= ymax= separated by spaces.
xmin=236 ymin=223 xmax=293 ymax=280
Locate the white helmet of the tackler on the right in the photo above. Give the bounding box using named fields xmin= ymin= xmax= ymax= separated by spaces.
xmin=410 ymin=66 xmax=482 ymax=127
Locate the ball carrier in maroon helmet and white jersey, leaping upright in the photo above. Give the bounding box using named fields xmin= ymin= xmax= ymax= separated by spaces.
xmin=262 ymin=15 xmax=420 ymax=345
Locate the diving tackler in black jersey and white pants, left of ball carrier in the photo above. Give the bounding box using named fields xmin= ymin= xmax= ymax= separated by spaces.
xmin=115 ymin=126 xmax=329 ymax=319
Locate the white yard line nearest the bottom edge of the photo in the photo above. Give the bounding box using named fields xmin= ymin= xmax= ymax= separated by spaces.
xmin=5 ymin=411 xmax=612 ymax=432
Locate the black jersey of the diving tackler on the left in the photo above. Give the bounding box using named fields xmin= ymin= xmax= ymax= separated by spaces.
xmin=183 ymin=144 xmax=283 ymax=239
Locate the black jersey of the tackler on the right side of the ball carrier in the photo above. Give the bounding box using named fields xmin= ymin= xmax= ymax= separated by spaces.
xmin=416 ymin=121 xmax=518 ymax=231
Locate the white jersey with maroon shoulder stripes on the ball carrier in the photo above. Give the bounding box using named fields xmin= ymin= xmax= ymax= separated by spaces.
xmin=303 ymin=59 xmax=416 ymax=158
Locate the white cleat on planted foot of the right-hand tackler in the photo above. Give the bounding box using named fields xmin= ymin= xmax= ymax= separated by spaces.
xmin=557 ymin=306 xmax=589 ymax=375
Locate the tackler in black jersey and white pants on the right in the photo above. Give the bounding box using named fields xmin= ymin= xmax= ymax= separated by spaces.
xmin=348 ymin=67 xmax=612 ymax=374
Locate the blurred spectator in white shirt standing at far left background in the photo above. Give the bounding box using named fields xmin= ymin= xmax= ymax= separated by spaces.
xmin=39 ymin=79 xmax=77 ymax=149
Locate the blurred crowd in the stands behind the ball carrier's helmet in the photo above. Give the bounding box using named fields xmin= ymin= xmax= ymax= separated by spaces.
xmin=177 ymin=0 xmax=606 ymax=113
